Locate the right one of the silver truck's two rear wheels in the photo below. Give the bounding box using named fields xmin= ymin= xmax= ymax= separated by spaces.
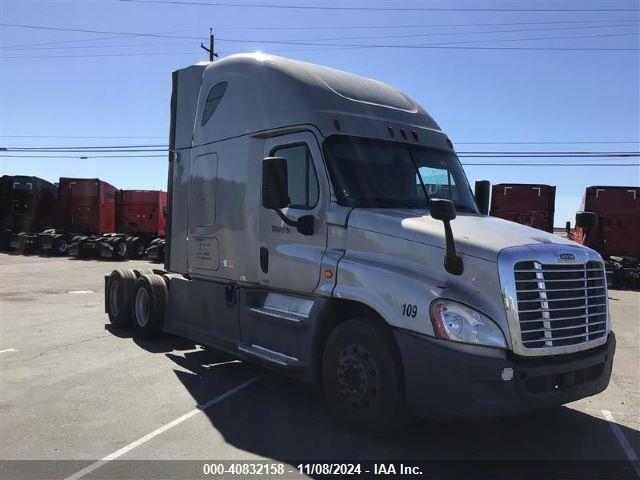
xmin=133 ymin=273 xmax=168 ymax=339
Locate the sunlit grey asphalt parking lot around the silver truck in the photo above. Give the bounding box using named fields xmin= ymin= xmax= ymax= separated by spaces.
xmin=0 ymin=254 xmax=640 ymax=478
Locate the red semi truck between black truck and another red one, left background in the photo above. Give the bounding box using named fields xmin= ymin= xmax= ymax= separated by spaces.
xmin=39 ymin=177 xmax=121 ymax=256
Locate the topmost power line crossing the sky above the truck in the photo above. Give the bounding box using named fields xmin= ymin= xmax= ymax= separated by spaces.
xmin=116 ymin=0 xmax=640 ymax=13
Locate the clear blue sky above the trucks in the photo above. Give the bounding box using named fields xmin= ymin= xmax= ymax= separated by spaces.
xmin=0 ymin=0 xmax=640 ymax=226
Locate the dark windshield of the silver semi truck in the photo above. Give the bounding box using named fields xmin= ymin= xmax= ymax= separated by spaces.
xmin=324 ymin=135 xmax=478 ymax=213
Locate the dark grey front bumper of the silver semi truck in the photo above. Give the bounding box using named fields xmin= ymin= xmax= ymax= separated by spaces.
xmin=394 ymin=330 xmax=616 ymax=418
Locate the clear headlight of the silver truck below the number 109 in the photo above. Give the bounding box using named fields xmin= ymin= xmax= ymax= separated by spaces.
xmin=431 ymin=300 xmax=507 ymax=348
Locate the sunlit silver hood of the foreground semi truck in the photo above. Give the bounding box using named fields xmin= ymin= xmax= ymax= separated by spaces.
xmin=349 ymin=208 xmax=584 ymax=262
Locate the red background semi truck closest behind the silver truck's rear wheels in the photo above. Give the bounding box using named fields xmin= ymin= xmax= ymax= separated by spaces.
xmin=98 ymin=190 xmax=167 ymax=259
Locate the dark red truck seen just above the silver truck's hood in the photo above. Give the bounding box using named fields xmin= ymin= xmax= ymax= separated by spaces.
xmin=490 ymin=183 xmax=556 ymax=233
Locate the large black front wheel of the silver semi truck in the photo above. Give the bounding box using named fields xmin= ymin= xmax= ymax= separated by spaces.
xmin=322 ymin=319 xmax=406 ymax=434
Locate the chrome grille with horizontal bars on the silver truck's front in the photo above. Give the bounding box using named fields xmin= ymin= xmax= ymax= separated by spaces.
xmin=514 ymin=261 xmax=607 ymax=349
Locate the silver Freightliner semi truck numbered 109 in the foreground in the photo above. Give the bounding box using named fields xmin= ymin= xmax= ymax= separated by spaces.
xmin=104 ymin=53 xmax=616 ymax=433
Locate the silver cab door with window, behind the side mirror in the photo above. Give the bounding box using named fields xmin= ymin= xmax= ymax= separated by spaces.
xmin=256 ymin=132 xmax=329 ymax=294
